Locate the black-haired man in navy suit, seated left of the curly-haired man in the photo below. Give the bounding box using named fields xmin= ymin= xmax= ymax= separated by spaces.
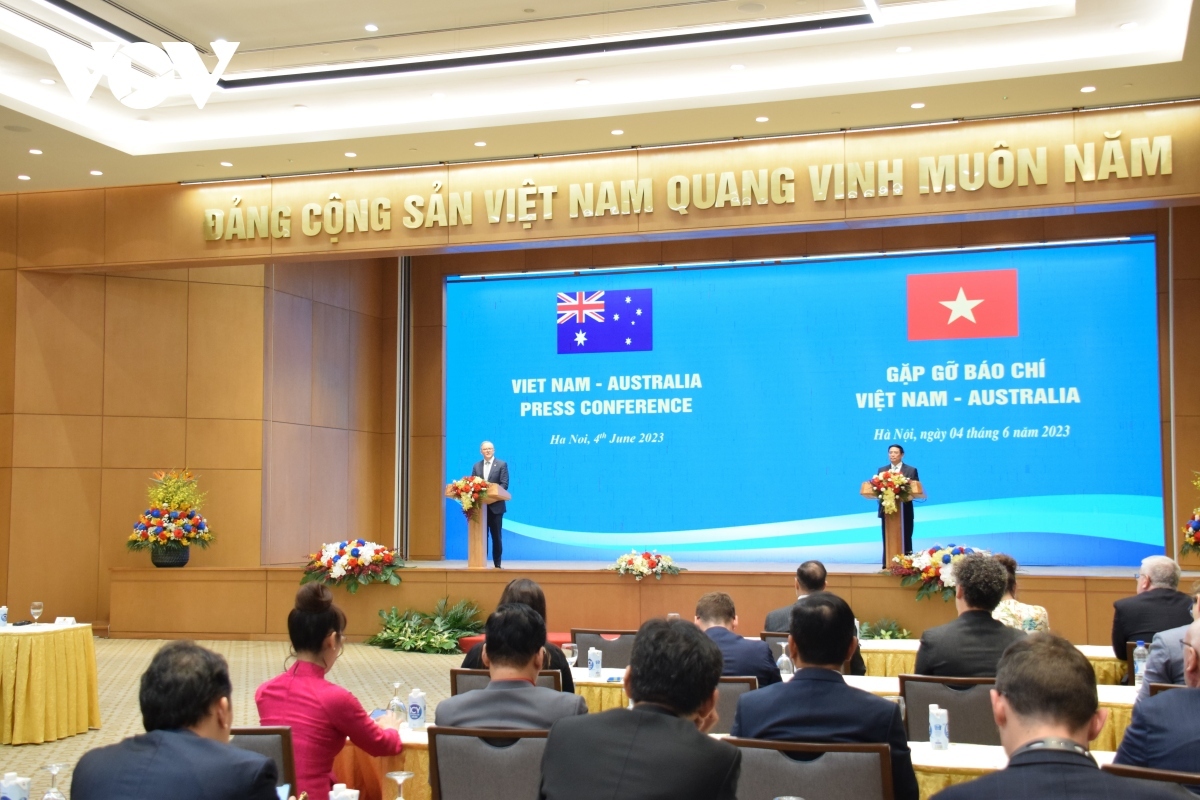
xmin=731 ymin=593 xmax=918 ymax=800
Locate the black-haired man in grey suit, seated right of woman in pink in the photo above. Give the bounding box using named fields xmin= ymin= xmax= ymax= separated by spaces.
xmin=434 ymin=603 xmax=588 ymax=729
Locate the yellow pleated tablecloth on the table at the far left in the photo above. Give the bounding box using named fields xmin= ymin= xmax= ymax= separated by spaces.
xmin=0 ymin=625 xmax=100 ymax=745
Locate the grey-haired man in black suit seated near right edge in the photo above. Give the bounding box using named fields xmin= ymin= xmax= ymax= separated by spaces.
xmin=1112 ymin=555 xmax=1192 ymax=662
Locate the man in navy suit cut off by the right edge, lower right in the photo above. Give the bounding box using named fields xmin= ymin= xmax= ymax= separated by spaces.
xmin=1114 ymin=622 xmax=1200 ymax=772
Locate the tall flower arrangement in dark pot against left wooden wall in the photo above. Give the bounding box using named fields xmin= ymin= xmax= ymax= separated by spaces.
xmin=125 ymin=470 xmax=214 ymax=567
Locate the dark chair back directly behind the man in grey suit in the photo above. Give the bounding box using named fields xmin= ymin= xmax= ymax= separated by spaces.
xmin=428 ymin=726 xmax=548 ymax=800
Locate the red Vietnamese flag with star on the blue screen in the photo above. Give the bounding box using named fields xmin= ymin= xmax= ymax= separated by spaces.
xmin=908 ymin=270 xmax=1018 ymax=341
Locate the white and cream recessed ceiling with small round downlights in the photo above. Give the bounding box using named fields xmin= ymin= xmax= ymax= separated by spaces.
xmin=0 ymin=0 xmax=1200 ymax=191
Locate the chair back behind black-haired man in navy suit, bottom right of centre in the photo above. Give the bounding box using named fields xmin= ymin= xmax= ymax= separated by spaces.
xmin=725 ymin=736 xmax=893 ymax=800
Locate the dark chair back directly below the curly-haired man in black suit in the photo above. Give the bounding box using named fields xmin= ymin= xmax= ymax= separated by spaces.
xmin=900 ymin=675 xmax=1000 ymax=745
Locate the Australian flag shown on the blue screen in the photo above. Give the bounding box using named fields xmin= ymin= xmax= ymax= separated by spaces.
xmin=557 ymin=289 xmax=654 ymax=355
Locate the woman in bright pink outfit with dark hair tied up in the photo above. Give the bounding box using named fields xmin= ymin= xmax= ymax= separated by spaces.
xmin=254 ymin=583 xmax=401 ymax=800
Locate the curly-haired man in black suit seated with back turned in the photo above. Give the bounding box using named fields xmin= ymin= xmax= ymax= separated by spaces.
xmin=916 ymin=553 xmax=1025 ymax=678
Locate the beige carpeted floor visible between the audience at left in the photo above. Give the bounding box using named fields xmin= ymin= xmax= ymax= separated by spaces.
xmin=0 ymin=639 xmax=462 ymax=800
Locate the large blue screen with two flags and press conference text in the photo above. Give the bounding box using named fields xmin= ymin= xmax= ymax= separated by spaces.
xmin=445 ymin=240 xmax=1163 ymax=565
